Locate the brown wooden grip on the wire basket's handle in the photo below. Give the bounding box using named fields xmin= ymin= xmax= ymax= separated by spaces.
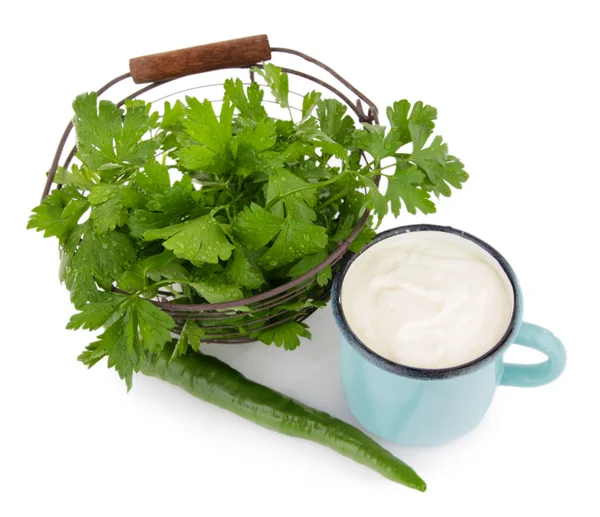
xmin=129 ymin=34 xmax=271 ymax=84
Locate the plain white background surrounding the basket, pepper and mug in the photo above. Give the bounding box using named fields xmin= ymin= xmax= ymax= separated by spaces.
xmin=0 ymin=0 xmax=600 ymax=517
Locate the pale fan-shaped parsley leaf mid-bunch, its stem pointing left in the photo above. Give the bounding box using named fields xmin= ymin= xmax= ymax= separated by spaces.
xmin=144 ymin=214 xmax=234 ymax=265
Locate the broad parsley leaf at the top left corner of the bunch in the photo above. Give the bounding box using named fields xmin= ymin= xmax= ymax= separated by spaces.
xmin=73 ymin=92 xmax=158 ymax=174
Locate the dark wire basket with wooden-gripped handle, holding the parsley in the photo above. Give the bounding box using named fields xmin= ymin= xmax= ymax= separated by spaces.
xmin=42 ymin=35 xmax=379 ymax=344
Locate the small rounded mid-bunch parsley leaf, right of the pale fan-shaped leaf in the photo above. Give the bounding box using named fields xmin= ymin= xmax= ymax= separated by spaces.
xmin=233 ymin=203 xmax=283 ymax=250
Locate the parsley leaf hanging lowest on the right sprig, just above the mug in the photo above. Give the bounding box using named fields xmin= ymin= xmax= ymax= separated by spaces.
xmin=385 ymin=162 xmax=435 ymax=217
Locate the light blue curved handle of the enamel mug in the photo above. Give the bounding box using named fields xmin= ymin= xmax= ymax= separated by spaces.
xmin=500 ymin=322 xmax=567 ymax=388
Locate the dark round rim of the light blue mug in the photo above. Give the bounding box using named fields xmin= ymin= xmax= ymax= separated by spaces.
xmin=332 ymin=224 xmax=523 ymax=379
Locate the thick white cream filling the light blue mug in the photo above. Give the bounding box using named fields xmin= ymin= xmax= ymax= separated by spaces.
xmin=341 ymin=231 xmax=514 ymax=368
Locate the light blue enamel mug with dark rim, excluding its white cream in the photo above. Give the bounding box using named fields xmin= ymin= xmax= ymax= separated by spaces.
xmin=332 ymin=224 xmax=566 ymax=446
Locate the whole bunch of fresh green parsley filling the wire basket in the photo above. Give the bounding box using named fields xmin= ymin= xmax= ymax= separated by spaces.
xmin=28 ymin=64 xmax=468 ymax=387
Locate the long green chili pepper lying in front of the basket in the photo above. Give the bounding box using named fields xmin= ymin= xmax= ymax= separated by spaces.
xmin=141 ymin=345 xmax=426 ymax=492
